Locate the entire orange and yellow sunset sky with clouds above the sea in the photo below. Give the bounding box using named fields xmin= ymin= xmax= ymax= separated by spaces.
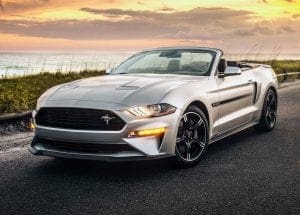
xmin=0 ymin=0 xmax=300 ymax=54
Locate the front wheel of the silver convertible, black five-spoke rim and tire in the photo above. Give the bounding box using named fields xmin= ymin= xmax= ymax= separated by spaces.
xmin=175 ymin=105 xmax=209 ymax=168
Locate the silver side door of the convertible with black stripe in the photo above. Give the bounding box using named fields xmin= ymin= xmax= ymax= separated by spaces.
xmin=213 ymin=72 xmax=256 ymax=133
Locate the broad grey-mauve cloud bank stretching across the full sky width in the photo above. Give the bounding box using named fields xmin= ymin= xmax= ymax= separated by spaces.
xmin=0 ymin=7 xmax=300 ymax=51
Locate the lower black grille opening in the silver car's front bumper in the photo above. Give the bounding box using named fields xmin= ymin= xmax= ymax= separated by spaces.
xmin=35 ymin=138 xmax=134 ymax=154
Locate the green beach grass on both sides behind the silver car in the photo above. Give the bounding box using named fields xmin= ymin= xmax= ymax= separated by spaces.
xmin=0 ymin=60 xmax=300 ymax=115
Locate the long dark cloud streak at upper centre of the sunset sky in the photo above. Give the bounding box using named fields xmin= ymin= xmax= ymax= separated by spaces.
xmin=81 ymin=7 xmax=254 ymax=28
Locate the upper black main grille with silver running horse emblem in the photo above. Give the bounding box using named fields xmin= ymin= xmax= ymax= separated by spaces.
xmin=35 ymin=108 xmax=125 ymax=131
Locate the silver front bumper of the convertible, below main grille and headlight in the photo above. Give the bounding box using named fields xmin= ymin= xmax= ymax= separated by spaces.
xmin=29 ymin=105 xmax=180 ymax=161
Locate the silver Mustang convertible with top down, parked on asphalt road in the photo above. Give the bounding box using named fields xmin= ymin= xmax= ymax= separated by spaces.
xmin=29 ymin=47 xmax=277 ymax=167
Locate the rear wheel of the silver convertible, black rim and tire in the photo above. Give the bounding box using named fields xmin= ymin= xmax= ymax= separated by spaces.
xmin=254 ymin=89 xmax=278 ymax=131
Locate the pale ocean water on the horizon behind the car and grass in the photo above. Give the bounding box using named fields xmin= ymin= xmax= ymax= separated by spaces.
xmin=0 ymin=51 xmax=300 ymax=78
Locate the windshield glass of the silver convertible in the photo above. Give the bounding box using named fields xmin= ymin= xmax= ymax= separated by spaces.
xmin=113 ymin=49 xmax=215 ymax=76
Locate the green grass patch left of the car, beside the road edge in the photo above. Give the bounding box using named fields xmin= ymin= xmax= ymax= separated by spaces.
xmin=0 ymin=71 xmax=104 ymax=115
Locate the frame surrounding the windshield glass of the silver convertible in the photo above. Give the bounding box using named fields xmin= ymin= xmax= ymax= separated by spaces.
xmin=111 ymin=48 xmax=217 ymax=77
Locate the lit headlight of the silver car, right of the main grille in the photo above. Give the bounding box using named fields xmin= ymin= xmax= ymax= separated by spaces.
xmin=127 ymin=103 xmax=176 ymax=117
